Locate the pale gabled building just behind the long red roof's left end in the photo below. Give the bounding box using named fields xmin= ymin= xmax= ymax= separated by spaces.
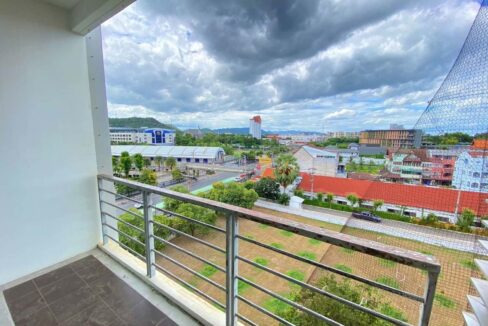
xmin=293 ymin=146 xmax=339 ymax=176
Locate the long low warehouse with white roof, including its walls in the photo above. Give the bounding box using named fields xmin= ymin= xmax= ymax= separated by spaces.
xmin=112 ymin=145 xmax=225 ymax=164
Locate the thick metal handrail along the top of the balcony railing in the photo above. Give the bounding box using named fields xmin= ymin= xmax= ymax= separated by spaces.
xmin=98 ymin=174 xmax=440 ymax=273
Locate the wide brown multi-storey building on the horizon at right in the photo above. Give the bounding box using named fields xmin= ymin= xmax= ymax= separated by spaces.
xmin=359 ymin=129 xmax=422 ymax=148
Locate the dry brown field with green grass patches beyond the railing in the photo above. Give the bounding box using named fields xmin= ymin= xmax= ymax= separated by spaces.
xmin=157 ymin=208 xmax=477 ymax=325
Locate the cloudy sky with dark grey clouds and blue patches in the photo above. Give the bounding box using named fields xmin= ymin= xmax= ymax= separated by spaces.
xmin=103 ymin=0 xmax=479 ymax=132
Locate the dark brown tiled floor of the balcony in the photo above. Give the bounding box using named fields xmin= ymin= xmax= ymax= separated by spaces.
xmin=4 ymin=256 xmax=176 ymax=326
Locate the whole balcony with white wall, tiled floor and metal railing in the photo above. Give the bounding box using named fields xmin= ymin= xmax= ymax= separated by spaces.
xmin=0 ymin=0 xmax=440 ymax=325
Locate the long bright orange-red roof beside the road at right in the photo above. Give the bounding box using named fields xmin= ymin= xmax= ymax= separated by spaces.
xmin=263 ymin=168 xmax=488 ymax=216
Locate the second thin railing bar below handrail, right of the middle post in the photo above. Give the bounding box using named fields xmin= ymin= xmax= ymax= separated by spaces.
xmin=237 ymin=256 xmax=409 ymax=326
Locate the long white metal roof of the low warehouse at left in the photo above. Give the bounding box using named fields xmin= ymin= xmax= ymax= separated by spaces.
xmin=112 ymin=145 xmax=225 ymax=159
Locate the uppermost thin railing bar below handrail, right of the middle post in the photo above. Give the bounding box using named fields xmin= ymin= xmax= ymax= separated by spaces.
xmin=237 ymin=235 xmax=425 ymax=303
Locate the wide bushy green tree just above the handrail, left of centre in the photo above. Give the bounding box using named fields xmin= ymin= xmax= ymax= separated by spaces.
xmin=201 ymin=182 xmax=259 ymax=208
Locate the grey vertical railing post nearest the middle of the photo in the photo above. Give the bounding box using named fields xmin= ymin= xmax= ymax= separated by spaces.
xmin=225 ymin=213 xmax=239 ymax=326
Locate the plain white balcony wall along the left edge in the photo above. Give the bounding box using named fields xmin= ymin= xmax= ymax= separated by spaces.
xmin=0 ymin=0 xmax=99 ymax=284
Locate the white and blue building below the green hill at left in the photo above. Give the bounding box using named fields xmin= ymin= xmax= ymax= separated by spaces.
xmin=110 ymin=127 xmax=176 ymax=145
